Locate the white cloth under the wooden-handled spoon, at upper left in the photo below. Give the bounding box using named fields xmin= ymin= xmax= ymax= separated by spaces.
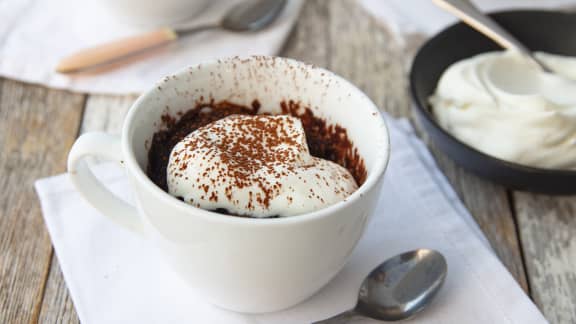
xmin=0 ymin=0 xmax=304 ymax=94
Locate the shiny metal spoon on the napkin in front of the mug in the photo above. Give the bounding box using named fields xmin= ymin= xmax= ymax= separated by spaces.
xmin=316 ymin=249 xmax=448 ymax=324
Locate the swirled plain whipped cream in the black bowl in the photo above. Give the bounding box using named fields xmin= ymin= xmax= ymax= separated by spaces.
xmin=430 ymin=52 xmax=576 ymax=169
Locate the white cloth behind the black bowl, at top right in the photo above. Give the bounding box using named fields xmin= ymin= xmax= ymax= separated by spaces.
xmin=360 ymin=0 xmax=576 ymax=36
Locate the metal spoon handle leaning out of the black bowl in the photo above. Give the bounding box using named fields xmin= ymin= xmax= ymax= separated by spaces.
xmin=432 ymin=0 xmax=551 ymax=73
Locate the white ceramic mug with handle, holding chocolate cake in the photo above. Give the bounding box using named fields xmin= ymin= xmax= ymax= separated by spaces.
xmin=68 ymin=56 xmax=389 ymax=313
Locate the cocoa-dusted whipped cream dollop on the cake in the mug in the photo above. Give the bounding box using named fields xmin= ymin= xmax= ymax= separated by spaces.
xmin=167 ymin=115 xmax=358 ymax=217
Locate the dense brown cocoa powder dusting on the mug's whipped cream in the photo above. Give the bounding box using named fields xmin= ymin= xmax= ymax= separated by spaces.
xmin=168 ymin=115 xmax=312 ymax=210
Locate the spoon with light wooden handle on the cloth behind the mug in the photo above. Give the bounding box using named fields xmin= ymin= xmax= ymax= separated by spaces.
xmin=56 ymin=0 xmax=286 ymax=73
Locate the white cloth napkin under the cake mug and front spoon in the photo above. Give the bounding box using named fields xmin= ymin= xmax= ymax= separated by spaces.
xmin=36 ymin=118 xmax=546 ymax=324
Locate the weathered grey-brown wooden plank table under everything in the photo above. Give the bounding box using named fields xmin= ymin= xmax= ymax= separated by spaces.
xmin=0 ymin=0 xmax=576 ymax=323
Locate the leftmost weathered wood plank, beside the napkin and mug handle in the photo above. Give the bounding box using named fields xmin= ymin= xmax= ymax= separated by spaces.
xmin=0 ymin=80 xmax=84 ymax=323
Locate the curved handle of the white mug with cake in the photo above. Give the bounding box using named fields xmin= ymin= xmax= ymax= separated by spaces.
xmin=68 ymin=132 xmax=143 ymax=233
